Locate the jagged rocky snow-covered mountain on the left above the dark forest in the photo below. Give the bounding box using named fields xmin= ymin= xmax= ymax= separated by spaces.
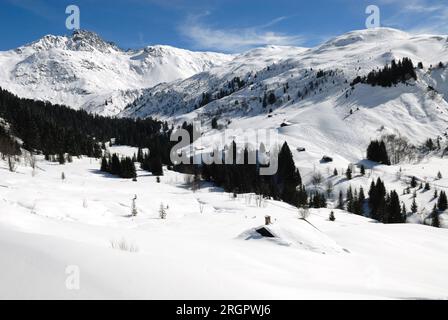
xmin=0 ymin=31 xmax=233 ymax=115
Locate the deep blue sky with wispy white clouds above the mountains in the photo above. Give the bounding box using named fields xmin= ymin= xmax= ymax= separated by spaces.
xmin=0 ymin=0 xmax=448 ymax=52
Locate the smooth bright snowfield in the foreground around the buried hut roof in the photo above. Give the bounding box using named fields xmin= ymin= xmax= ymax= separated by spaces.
xmin=0 ymin=155 xmax=448 ymax=299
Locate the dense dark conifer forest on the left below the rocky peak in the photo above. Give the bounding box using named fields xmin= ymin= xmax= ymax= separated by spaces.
xmin=0 ymin=88 xmax=172 ymax=159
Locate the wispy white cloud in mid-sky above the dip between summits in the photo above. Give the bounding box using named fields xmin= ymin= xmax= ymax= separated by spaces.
xmin=179 ymin=12 xmax=305 ymax=52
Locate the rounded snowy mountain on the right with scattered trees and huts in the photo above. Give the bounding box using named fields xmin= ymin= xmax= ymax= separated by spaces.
xmin=121 ymin=28 xmax=448 ymax=166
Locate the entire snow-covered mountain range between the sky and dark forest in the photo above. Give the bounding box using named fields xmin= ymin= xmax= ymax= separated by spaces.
xmin=0 ymin=28 xmax=448 ymax=166
